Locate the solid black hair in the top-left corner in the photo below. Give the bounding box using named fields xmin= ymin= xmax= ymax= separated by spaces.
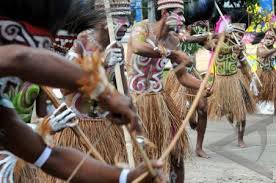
xmin=0 ymin=0 xmax=73 ymax=31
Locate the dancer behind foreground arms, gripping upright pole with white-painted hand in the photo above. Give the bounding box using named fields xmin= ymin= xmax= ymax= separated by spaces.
xmin=46 ymin=0 xmax=133 ymax=171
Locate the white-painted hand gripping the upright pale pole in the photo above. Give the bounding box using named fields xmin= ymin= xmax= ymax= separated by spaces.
xmin=105 ymin=41 xmax=124 ymax=66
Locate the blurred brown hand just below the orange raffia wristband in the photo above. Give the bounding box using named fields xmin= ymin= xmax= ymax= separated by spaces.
xmin=99 ymin=91 xmax=142 ymax=134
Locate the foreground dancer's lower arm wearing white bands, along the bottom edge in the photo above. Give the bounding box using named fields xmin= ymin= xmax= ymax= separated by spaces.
xmin=0 ymin=106 xmax=162 ymax=183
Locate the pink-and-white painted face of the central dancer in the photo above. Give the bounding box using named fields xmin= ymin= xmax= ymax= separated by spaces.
xmin=166 ymin=8 xmax=185 ymax=33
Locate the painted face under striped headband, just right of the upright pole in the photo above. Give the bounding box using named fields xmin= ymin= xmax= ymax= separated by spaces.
xmin=112 ymin=16 xmax=130 ymax=41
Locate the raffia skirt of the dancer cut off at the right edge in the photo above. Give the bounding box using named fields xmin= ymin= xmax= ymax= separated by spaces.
xmin=257 ymin=69 xmax=276 ymax=103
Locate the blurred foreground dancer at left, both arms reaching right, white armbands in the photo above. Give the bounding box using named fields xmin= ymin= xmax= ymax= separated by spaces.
xmin=0 ymin=0 xmax=164 ymax=183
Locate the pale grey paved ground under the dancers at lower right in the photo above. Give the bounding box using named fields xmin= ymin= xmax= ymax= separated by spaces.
xmin=186 ymin=115 xmax=276 ymax=183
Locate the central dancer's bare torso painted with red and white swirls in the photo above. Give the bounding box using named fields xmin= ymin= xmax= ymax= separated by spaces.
xmin=128 ymin=21 xmax=178 ymax=93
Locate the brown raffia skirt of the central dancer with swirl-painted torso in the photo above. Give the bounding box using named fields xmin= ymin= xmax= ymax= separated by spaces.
xmin=132 ymin=92 xmax=189 ymax=172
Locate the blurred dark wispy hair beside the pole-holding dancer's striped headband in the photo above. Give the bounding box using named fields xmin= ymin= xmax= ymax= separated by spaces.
xmin=63 ymin=0 xmax=105 ymax=34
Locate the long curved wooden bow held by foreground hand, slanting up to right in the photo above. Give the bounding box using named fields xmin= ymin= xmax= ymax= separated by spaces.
xmin=132 ymin=35 xmax=225 ymax=183
